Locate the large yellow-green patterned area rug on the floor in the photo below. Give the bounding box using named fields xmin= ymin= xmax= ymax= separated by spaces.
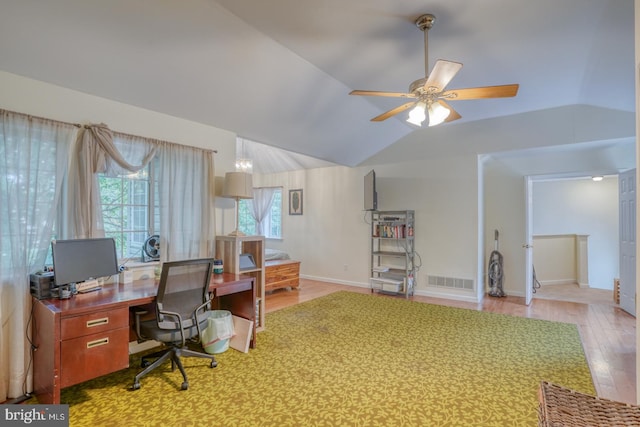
xmin=56 ymin=292 xmax=594 ymax=427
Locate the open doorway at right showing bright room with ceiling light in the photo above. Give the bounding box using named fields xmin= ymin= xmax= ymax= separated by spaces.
xmin=527 ymin=175 xmax=619 ymax=305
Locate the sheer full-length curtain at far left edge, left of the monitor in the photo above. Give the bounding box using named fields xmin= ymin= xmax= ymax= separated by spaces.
xmin=0 ymin=110 xmax=78 ymax=401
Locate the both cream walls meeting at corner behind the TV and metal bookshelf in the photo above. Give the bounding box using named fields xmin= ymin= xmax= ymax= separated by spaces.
xmin=254 ymin=157 xmax=478 ymax=300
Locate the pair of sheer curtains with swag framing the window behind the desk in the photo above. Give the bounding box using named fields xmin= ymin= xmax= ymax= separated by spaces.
xmin=69 ymin=124 xmax=215 ymax=261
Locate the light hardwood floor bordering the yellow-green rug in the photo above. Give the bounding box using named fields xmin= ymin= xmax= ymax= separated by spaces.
xmin=266 ymin=279 xmax=637 ymax=404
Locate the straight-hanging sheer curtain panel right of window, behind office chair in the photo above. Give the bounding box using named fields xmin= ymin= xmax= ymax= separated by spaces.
xmin=157 ymin=143 xmax=215 ymax=261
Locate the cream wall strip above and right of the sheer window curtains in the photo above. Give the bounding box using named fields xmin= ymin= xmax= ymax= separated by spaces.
xmin=0 ymin=71 xmax=236 ymax=234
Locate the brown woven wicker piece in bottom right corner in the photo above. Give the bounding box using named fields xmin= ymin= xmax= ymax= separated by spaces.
xmin=538 ymin=381 xmax=640 ymax=427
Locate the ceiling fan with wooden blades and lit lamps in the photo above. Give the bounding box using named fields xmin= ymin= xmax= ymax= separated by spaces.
xmin=349 ymin=14 xmax=519 ymax=126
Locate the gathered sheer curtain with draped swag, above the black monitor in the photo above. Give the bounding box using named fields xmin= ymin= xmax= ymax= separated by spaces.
xmin=67 ymin=124 xmax=156 ymax=238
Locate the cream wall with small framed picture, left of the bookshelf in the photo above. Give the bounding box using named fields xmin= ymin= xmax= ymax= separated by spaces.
xmin=254 ymin=166 xmax=369 ymax=286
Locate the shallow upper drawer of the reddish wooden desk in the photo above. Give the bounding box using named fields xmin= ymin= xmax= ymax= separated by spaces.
xmin=60 ymin=307 xmax=129 ymax=340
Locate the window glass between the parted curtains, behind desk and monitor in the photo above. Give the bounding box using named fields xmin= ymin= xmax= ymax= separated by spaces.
xmin=98 ymin=162 xmax=160 ymax=259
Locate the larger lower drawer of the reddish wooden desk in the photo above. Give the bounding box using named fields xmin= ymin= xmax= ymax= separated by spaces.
xmin=60 ymin=325 xmax=129 ymax=387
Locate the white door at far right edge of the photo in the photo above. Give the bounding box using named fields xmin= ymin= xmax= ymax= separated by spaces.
xmin=618 ymin=169 xmax=636 ymax=316
